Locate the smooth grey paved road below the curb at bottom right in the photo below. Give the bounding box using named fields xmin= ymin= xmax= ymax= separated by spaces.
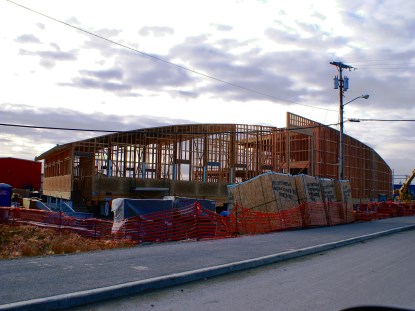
xmin=71 ymin=231 xmax=415 ymax=311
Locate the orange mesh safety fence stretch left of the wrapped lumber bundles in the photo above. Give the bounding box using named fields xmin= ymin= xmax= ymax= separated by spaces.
xmin=0 ymin=202 xmax=231 ymax=243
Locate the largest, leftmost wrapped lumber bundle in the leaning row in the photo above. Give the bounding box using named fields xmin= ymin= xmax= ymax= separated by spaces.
xmin=228 ymin=172 xmax=301 ymax=231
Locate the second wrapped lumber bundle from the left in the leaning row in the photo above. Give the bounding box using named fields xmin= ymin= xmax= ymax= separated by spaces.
xmin=295 ymin=175 xmax=328 ymax=227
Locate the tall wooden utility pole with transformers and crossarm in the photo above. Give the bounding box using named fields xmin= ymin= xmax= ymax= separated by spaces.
xmin=330 ymin=62 xmax=355 ymax=180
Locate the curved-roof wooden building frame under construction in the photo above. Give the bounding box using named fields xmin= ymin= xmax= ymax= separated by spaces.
xmin=37 ymin=113 xmax=392 ymax=213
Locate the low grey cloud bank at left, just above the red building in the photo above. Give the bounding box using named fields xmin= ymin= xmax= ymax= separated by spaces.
xmin=0 ymin=103 xmax=195 ymax=159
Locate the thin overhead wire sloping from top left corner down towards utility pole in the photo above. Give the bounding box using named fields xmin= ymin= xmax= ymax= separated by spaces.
xmin=6 ymin=0 xmax=337 ymax=112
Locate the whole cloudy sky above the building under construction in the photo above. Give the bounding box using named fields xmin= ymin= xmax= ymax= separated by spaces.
xmin=0 ymin=0 xmax=415 ymax=183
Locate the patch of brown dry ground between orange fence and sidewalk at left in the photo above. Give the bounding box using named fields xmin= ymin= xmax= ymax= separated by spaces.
xmin=0 ymin=224 xmax=135 ymax=259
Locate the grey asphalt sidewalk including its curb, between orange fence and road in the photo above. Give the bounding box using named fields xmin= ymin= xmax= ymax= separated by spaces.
xmin=0 ymin=216 xmax=415 ymax=310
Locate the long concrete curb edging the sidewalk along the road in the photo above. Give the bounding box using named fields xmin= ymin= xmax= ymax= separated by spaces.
xmin=0 ymin=225 xmax=415 ymax=311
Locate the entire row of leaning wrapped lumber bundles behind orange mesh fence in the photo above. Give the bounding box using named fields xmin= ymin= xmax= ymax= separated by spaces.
xmin=228 ymin=172 xmax=355 ymax=233
